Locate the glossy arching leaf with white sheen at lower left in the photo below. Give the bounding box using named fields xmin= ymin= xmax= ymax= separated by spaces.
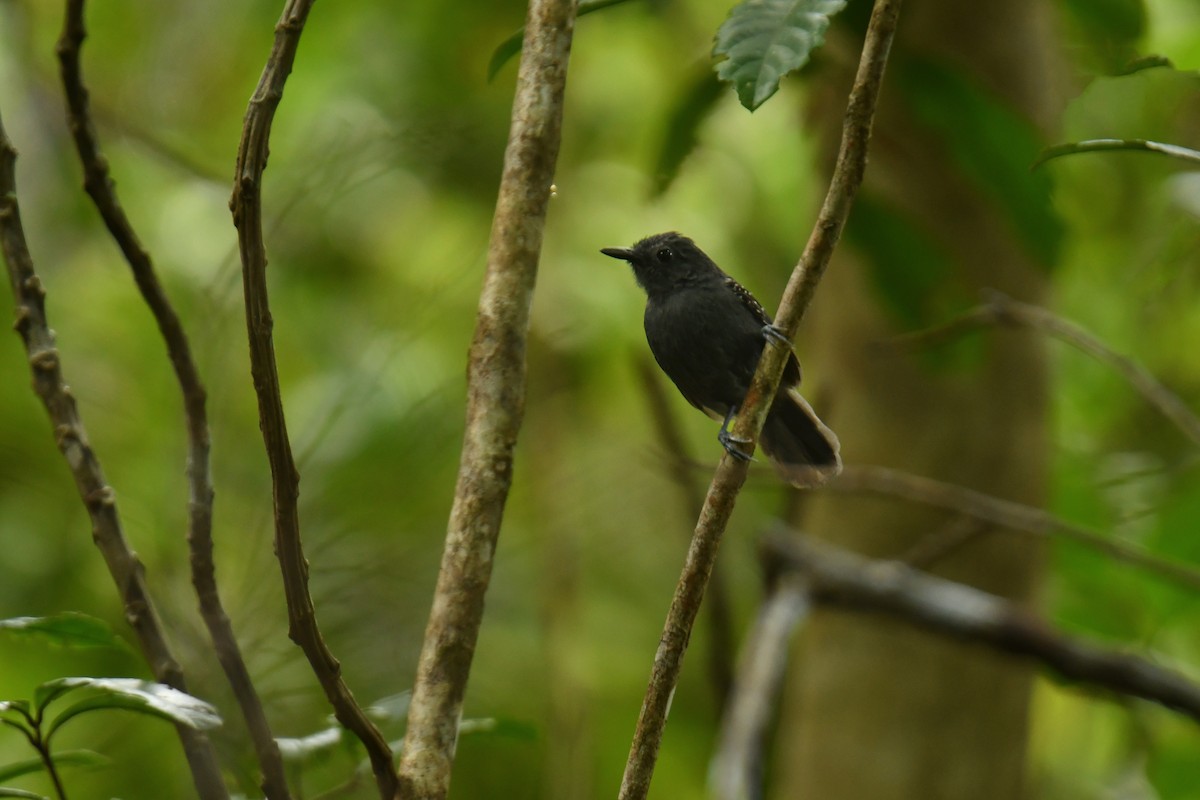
xmin=35 ymin=678 xmax=221 ymax=738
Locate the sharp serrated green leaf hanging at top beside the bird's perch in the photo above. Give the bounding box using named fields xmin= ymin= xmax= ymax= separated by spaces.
xmin=713 ymin=0 xmax=846 ymax=112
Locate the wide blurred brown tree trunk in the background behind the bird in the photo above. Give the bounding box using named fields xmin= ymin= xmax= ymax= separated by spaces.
xmin=774 ymin=0 xmax=1060 ymax=800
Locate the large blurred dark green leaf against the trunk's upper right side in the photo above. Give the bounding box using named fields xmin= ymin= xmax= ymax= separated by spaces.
xmin=896 ymin=59 xmax=1063 ymax=270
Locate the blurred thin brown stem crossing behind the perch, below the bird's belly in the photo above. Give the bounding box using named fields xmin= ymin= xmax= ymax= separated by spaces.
xmin=637 ymin=359 xmax=734 ymax=714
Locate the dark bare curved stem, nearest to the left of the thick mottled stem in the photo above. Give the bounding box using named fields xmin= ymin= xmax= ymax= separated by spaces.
xmin=229 ymin=0 xmax=396 ymax=800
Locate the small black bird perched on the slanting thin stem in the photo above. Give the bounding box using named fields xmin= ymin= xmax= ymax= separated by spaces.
xmin=600 ymin=233 xmax=841 ymax=486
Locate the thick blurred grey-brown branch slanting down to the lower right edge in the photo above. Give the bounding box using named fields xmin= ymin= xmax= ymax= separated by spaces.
xmin=766 ymin=533 xmax=1200 ymax=722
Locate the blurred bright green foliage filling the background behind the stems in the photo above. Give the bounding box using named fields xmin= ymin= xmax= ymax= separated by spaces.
xmin=0 ymin=0 xmax=1200 ymax=800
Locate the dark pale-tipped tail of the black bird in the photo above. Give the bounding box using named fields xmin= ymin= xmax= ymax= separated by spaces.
xmin=762 ymin=387 xmax=841 ymax=488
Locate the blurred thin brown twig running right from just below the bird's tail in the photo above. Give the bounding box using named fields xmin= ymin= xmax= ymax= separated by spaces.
xmin=824 ymin=465 xmax=1200 ymax=591
